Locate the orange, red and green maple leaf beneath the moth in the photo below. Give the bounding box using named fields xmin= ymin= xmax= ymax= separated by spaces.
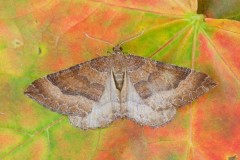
xmin=0 ymin=0 xmax=240 ymax=160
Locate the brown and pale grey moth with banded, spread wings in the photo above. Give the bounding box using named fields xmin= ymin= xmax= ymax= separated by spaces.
xmin=25 ymin=45 xmax=216 ymax=129
